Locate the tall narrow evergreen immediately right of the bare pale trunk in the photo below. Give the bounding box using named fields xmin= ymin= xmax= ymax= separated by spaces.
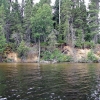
xmin=59 ymin=0 xmax=72 ymax=44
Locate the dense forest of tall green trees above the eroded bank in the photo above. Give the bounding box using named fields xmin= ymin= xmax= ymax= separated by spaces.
xmin=0 ymin=0 xmax=100 ymax=62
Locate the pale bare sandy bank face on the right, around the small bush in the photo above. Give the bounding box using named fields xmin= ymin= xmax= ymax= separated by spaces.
xmin=62 ymin=46 xmax=100 ymax=62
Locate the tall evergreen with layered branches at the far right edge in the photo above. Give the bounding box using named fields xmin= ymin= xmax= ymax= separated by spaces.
xmin=88 ymin=0 xmax=99 ymax=43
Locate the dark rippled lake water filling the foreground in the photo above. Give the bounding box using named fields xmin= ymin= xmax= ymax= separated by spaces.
xmin=0 ymin=63 xmax=100 ymax=100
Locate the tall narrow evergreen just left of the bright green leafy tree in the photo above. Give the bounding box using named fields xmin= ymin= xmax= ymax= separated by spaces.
xmin=24 ymin=0 xmax=33 ymax=42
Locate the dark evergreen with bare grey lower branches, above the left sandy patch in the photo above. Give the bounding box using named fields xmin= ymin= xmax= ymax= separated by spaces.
xmin=10 ymin=0 xmax=23 ymax=47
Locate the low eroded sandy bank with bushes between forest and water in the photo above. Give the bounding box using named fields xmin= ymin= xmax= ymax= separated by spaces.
xmin=3 ymin=45 xmax=100 ymax=63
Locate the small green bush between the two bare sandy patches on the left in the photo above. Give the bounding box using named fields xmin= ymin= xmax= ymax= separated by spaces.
xmin=17 ymin=41 xmax=29 ymax=57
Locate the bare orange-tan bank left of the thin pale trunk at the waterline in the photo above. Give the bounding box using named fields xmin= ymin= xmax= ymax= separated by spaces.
xmin=7 ymin=45 xmax=38 ymax=63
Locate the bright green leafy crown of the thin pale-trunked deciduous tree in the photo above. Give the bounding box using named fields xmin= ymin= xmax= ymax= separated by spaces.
xmin=31 ymin=4 xmax=53 ymax=38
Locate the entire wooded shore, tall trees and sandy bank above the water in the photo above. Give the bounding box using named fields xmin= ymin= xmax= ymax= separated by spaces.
xmin=0 ymin=0 xmax=100 ymax=62
